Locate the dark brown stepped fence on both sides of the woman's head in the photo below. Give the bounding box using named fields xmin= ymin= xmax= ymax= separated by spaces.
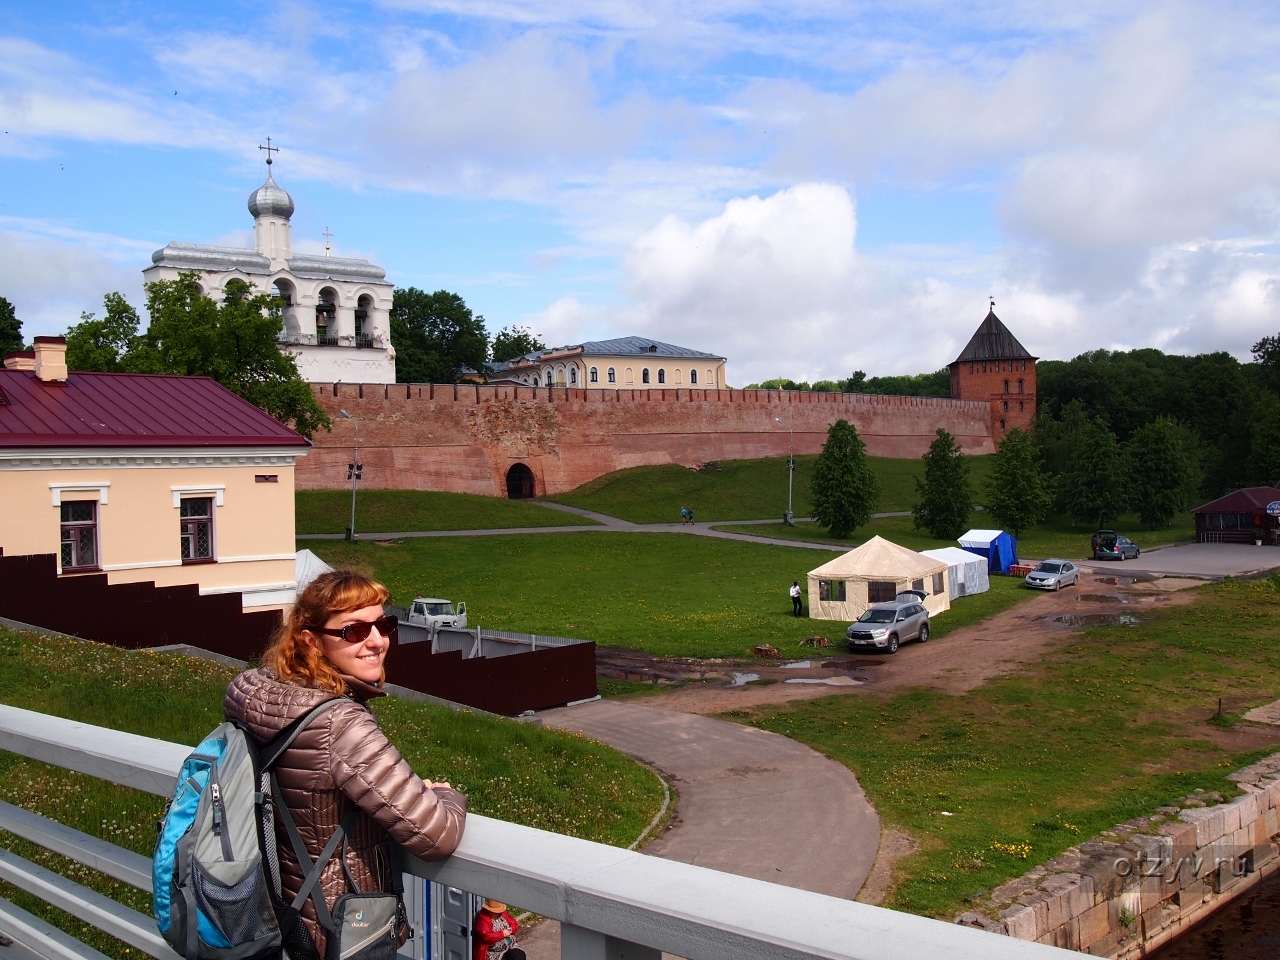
xmin=0 ymin=553 xmax=595 ymax=714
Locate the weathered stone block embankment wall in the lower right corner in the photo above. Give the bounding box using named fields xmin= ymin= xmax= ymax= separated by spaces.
xmin=956 ymin=754 xmax=1280 ymax=960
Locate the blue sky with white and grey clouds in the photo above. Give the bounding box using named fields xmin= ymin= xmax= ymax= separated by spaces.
xmin=0 ymin=0 xmax=1280 ymax=384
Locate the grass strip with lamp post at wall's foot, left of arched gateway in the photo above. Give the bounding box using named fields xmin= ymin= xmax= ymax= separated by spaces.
xmin=294 ymin=490 xmax=595 ymax=534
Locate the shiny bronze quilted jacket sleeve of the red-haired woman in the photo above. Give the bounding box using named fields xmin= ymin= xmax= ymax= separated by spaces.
xmin=329 ymin=704 xmax=467 ymax=860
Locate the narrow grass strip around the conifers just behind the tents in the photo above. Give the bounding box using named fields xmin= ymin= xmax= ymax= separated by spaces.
xmin=716 ymin=511 xmax=1196 ymax=567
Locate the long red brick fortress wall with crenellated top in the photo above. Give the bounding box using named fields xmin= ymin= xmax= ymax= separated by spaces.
xmin=296 ymin=384 xmax=995 ymax=497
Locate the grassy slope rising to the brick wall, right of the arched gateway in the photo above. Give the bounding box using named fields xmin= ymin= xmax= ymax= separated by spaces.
xmin=547 ymin=456 xmax=991 ymax=524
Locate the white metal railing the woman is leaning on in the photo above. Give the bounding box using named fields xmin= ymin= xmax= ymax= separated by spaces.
xmin=0 ymin=705 xmax=1075 ymax=960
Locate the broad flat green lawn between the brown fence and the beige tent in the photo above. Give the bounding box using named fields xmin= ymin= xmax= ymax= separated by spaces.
xmin=314 ymin=532 xmax=1030 ymax=657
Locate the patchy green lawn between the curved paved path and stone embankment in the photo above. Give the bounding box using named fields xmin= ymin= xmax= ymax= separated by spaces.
xmin=731 ymin=579 xmax=1280 ymax=919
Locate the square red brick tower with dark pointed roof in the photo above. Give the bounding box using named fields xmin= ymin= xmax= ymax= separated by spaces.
xmin=948 ymin=303 xmax=1037 ymax=442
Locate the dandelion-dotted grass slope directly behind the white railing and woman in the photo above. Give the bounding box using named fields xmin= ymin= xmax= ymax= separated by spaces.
xmin=0 ymin=628 xmax=662 ymax=960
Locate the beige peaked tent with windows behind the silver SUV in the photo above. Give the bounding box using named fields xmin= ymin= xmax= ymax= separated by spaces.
xmin=809 ymin=536 xmax=951 ymax=622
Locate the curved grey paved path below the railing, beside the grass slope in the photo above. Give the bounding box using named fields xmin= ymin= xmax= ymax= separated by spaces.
xmin=518 ymin=700 xmax=879 ymax=960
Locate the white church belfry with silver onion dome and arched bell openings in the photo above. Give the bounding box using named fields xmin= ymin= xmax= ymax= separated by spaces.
xmin=142 ymin=152 xmax=396 ymax=383
